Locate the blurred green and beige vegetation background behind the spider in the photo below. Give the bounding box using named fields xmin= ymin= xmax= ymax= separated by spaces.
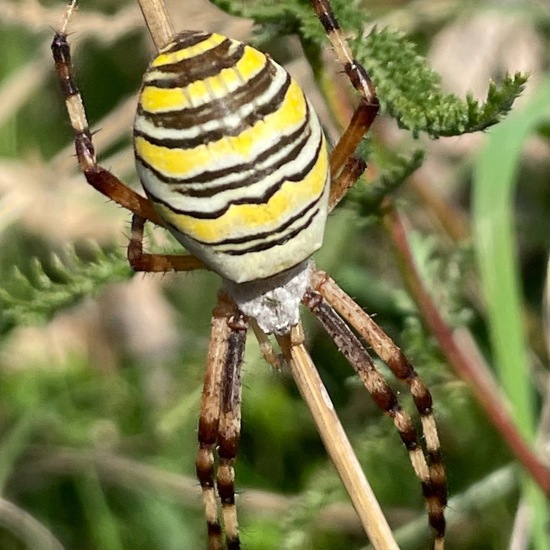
xmin=0 ymin=0 xmax=550 ymax=550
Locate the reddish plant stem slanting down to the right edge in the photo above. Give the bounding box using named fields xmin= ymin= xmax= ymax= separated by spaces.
xmin=385 ymin=207 xmax=550 ymax=496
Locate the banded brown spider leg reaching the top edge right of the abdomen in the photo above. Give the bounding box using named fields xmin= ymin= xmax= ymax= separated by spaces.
xmin=311 ymin=0 xmax=379 ymax=198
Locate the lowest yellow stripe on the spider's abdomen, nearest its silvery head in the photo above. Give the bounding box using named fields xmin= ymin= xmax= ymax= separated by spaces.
xmin=156 ymin=140 xmax=328 ymax=242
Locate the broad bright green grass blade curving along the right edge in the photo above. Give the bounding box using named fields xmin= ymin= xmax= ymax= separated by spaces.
xmin=472 ymin=77 xmax=550 ymax=549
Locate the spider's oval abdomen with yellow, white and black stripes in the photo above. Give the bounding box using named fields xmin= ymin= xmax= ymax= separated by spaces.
xmin=134 ymin=31 xmax=329 ymax=283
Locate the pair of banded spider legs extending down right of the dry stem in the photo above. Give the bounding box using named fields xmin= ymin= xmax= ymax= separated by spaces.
xmin=303 ymin=280 xmax=447 ymax=549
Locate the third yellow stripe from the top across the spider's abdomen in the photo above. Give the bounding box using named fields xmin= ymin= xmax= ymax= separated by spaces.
xmin=134 ymin=81 xmax=306 ymax=177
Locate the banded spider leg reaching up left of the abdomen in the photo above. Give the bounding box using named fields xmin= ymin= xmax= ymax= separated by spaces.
xmin=51 ymin=0 xmax=164 ymax=225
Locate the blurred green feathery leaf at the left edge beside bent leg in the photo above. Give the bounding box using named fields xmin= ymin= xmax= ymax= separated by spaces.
xmin=0 ymin=245 xmax=133 ymax=332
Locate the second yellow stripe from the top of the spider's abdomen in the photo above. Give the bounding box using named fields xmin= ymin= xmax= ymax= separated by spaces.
xmin=139 ymin=46 xmax=267 ymax=113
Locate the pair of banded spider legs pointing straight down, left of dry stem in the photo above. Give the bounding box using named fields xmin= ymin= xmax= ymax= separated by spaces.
xmin=196 ymin=293 xmax=248 ymax=550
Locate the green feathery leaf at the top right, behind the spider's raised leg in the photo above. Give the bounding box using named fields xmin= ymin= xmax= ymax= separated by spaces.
xmin=214 ymin=0 xmax=527 ymax=138
